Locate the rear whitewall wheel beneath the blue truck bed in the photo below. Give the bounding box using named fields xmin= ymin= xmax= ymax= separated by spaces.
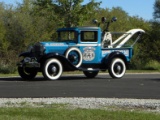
xmin=108 ymin=58 xmax=126 ymax=78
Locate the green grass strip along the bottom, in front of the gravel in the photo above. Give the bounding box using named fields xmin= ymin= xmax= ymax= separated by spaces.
xmin=0 ymin=106 xmax=160 ymax=120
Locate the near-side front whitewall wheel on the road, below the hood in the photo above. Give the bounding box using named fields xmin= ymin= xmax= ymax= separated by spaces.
xmin=42 ymin=58 xmax=63 ymax=80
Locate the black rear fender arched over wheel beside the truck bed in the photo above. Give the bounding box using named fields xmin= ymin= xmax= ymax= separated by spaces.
xmin=103 ymin=51 xmax=127 ymax=67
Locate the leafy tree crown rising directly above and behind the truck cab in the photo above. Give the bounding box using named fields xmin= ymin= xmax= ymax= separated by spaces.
xmin=35 ymin=0 xmax=101 ymax=27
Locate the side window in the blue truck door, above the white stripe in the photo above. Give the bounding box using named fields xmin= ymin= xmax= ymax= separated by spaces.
xmin=81 ymin=31 xmax=98 ymax=42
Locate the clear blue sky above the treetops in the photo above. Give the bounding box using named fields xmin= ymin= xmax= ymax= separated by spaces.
xmin=0 ymin=0 xmax=155 ymax=20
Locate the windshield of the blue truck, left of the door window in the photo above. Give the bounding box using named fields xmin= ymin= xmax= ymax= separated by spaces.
xmin=58 ymin=31 xmax=77 ymax=42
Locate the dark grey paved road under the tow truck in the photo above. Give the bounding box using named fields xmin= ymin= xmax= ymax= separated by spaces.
xmin=0 ymin=74 xmax=160 ymax=99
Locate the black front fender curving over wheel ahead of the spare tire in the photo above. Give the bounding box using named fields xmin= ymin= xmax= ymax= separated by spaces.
xmin=39 ymin=53 xmax=78 ymax=71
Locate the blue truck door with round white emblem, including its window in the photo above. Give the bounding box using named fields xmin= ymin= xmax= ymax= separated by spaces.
xmin=78 ymin=30 xmax=101 ymax=63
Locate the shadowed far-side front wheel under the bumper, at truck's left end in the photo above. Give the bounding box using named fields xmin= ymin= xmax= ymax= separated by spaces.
xmin=18 ymin=67 xmax=37 ymax=80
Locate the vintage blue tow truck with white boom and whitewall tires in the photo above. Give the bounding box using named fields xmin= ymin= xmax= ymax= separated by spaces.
xmin=17 ymin=17 xmax=144 ymax=80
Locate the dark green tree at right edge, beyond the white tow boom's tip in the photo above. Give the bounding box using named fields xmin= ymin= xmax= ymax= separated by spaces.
xmin=134 ymin=0 xmax=160 ymax=69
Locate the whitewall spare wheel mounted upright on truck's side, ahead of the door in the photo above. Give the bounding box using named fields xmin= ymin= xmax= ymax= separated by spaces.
xmin=65 ymin=47 xmax=82 ymax=67
